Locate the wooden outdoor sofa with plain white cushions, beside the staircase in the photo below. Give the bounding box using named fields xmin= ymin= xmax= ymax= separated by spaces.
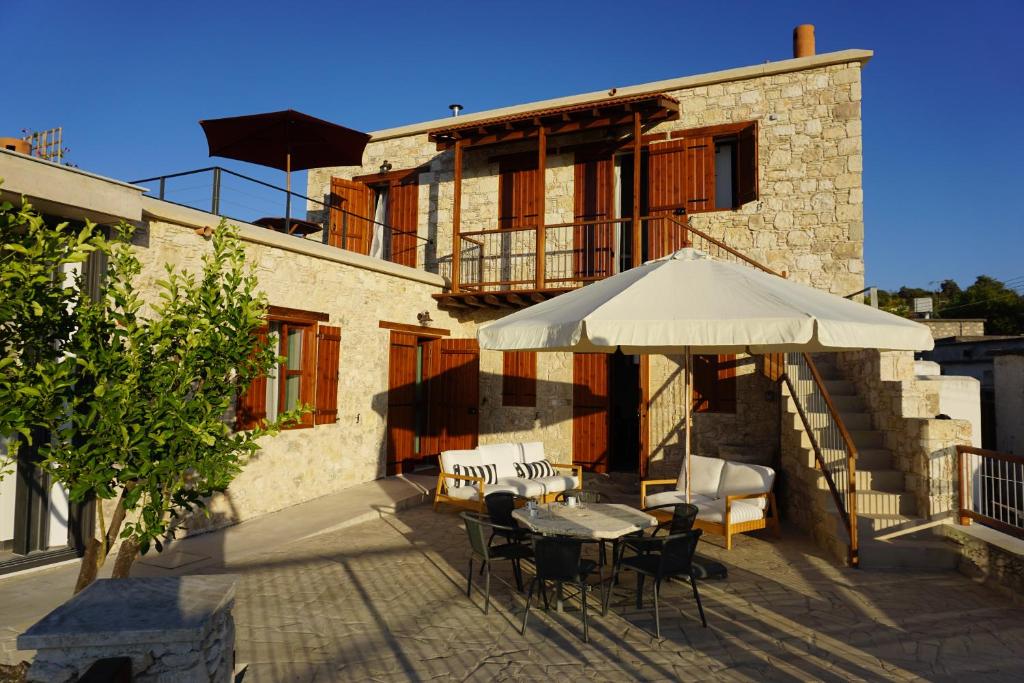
xmin=640 ymin=456 xmax=779 ymax=549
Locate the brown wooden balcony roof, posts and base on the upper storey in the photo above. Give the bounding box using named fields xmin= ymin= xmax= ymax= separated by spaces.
xmin=428 ymin=93 xmax=679 ymax=307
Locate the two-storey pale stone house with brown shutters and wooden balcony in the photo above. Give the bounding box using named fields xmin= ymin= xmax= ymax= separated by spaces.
xmin=0 ymin=30 xmax=983 ymax=571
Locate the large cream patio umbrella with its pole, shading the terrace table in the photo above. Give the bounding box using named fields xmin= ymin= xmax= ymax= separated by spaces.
xmin=477 ymin=249 xmax=934 ymax=500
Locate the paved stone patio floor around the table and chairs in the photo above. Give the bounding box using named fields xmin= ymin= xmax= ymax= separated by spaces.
xmin=0 ymin=481 xmax=1024 ymax=683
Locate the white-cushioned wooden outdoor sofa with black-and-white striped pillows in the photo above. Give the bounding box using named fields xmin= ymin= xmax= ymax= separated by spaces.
xmin=434 ymin=441 xmax=583 ymax=512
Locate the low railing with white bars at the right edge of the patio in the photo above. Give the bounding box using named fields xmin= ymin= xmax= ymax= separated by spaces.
xmin=956 ymin=445 xmax=1024 ymax=539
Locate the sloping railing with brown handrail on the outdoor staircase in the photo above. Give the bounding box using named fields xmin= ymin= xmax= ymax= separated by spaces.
xmin=781 ymin=353 xmax=859 ymax=566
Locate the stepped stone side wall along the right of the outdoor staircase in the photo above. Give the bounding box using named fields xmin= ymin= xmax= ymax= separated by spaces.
xmin=838 ymin=350 xmax=971 ymax=519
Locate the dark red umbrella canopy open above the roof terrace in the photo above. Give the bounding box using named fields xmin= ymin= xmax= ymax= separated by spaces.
xmin=199 ymin=110 xmax=370 ymax=171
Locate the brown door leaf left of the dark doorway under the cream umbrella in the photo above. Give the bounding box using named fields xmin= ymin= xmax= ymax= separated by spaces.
xmin=572 ymin=353 xmax=609 ymax=472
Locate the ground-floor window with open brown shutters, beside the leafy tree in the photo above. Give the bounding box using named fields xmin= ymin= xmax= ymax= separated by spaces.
xmin=236 ymin=306 xmax=341 ymax=429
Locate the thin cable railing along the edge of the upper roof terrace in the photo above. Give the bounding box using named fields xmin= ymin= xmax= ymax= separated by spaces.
xmin=132 ymin=166 xmax=436 ymax=270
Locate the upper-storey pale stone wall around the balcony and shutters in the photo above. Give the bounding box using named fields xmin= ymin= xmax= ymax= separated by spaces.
xmin=308 ymin=61 xmax=864 ymax=295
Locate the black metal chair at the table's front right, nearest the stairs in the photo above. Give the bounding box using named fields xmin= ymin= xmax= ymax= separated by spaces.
xmin=615 ymin=529 xmax=708 ymax=638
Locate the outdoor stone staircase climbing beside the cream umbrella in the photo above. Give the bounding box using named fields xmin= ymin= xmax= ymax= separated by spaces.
xmin=782 ymin=353 xmax=958 ymax=569
